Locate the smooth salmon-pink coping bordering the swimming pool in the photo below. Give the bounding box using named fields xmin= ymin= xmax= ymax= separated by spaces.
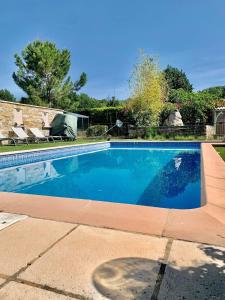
xmin=0 ymin=141 xmax=225 ymax=246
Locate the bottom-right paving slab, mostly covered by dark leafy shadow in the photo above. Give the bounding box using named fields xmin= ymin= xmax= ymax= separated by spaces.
xmin=158 ymin=241 xmax=225 ymax=300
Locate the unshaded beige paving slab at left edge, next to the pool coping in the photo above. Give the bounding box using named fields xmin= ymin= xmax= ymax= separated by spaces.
xmin=0 ymin=218 xmax=74 ymax=275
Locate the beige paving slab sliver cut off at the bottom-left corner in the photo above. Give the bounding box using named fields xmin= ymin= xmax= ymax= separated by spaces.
xmin=0 ymin=282 xmax=76 ymax=300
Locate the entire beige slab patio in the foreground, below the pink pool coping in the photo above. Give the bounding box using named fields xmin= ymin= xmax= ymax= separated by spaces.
xmin=0 ymin=218 xmax=225 ymax=300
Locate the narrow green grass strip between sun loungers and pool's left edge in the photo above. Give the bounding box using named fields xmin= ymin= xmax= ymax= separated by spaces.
xmin=0 ymin=138 xmax=106 ymax=152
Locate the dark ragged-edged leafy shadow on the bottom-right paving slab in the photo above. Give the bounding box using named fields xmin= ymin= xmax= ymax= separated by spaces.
xmin=161 ymin=245 xmax=225 ymax=300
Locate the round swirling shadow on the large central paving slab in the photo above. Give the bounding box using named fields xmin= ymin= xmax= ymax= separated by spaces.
xmin=92 ymin=257 xmax=160 ymax=300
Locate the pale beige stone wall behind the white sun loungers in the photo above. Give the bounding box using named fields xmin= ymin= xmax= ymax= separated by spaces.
xmin=0 ymin=100 xmax=63 ymax=136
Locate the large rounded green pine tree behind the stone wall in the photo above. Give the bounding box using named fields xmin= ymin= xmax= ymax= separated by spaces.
xmin=13 ymin=40 xmax=87 ymax=108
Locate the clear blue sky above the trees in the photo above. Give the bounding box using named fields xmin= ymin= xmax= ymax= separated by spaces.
xmin=0 ymin=0 xmax=225 ymax=98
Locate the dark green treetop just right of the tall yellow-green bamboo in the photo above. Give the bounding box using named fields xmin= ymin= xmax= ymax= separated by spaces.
xmin=164 ymin=65 xmax=193 ymax=92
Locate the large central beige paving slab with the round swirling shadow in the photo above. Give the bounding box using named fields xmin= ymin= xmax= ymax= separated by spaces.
xmin=20 ymin=226 xmax=167 ymax=300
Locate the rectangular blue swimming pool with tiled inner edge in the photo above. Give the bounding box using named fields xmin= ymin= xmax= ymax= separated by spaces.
xmin=0 ymin=142 xmax=201 ymax=209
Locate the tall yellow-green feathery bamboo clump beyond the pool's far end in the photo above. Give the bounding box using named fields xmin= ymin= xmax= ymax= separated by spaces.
xmin=128 ymin=53 xmax=167 ymax=126
